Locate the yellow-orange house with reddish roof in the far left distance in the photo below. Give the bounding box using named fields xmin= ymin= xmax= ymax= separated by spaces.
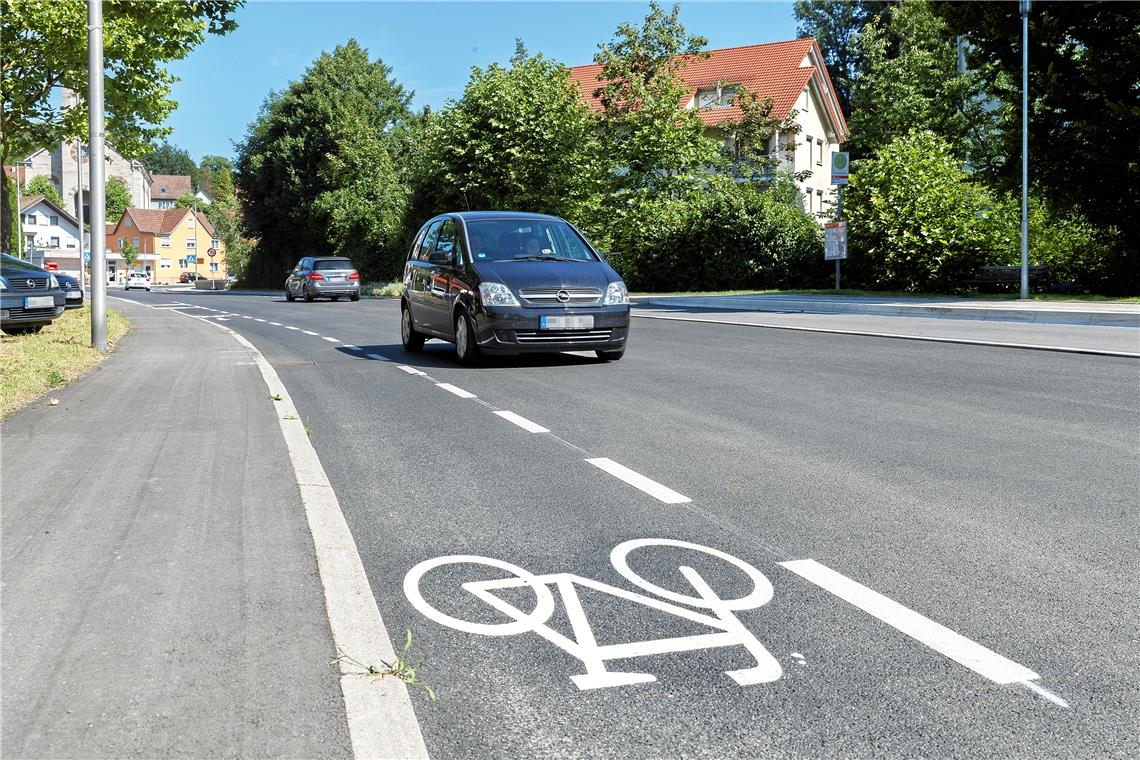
xmin=107 ymin=209 xmax=228 ymax=285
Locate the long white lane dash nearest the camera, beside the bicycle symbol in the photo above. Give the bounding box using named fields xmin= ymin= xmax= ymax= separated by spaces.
xmin=780 ymin=559 xmax=1039 ymax=684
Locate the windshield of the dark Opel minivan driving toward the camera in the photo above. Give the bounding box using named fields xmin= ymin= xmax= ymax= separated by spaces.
xmin=467 ymin=219 xmax=597 ymax=261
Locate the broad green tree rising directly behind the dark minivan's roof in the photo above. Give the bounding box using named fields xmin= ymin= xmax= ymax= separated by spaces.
xmin=428 ymin=43 xmax=602 ymax=216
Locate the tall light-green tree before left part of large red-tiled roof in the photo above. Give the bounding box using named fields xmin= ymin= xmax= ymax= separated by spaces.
xmin=594 ymin=2 xmax=719 ymax=194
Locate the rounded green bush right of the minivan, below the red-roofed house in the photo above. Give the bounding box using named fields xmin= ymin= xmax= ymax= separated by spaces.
xmin=611 ymin=181 xmax=829 ymax=291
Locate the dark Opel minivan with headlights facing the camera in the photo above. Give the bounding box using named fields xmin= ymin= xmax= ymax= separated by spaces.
xmin=400 ymin=211 xmax=629 ymax=363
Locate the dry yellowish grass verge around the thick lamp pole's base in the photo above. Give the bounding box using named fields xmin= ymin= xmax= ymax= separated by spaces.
xmin=0 ymin=304 xmax=131 ymax=419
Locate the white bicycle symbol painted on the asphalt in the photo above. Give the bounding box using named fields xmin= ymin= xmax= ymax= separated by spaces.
xmin=404 ymin=538 xmax=783 ymax=689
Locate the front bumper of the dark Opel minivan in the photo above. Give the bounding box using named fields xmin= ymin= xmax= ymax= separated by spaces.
xmin=474 ymin=304 xmax=629 ymax=353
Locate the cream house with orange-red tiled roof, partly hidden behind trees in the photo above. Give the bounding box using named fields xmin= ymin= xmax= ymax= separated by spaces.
xmin=570 ymin=38 xmax=847 ymax=214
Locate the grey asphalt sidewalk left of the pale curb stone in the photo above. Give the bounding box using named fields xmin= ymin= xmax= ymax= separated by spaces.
xmin=0 ymin=304 xmax=352 ymax=758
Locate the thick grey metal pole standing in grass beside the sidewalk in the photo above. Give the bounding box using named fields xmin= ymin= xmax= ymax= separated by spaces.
xmin=87 ymin=0 xmax=107 ymax=353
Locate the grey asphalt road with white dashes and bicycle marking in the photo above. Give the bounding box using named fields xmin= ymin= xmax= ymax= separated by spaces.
xmin=112 ymin=293 xmax=1140 ymax=759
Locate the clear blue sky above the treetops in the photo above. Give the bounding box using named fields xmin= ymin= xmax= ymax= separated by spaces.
xmin=168 ymin=0 xmax=796 ymax=161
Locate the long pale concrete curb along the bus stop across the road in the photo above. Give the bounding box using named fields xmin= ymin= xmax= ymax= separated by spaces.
xmin=636 ymin=296 xmax=1140 ymax=327
